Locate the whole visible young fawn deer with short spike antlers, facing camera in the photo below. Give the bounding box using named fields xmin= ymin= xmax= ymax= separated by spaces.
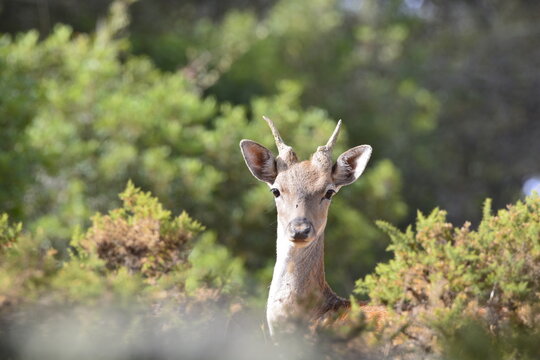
xmin=240 ymin=117 xmax=382 ymax=336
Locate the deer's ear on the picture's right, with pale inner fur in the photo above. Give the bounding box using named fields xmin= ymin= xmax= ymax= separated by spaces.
xmin=332 ymin=145 xmax=372 ymax=186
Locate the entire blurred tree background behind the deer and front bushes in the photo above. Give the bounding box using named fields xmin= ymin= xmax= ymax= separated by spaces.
xmin=0 ymin=0 xmax=540 ymax=294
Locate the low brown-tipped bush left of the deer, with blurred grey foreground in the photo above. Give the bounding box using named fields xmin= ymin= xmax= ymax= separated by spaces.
xmin=0 ymin=183 xmax=264 ymax=359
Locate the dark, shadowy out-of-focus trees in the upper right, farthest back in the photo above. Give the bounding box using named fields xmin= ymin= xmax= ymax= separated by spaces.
xmin=130 ymin=0 xmax=540 ymax=225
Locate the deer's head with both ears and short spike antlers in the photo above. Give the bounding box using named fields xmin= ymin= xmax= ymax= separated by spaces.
xmin=240 ymin=118 xmax=371 ymax=247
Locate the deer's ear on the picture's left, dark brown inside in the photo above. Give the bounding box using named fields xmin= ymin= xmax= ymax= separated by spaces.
xmin=240 ymin=140 xmax=277 ymax=185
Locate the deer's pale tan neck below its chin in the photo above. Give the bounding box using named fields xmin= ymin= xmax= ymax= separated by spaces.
xmin=267 ymin=225 xmax=333 ymax=333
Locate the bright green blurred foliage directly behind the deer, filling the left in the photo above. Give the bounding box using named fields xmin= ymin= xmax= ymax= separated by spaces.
xmin=0 ymin=3 xmax=406 ymax=291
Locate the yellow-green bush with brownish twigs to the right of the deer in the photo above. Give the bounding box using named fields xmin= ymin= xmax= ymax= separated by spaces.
xmin=356 ymin=195 xmax=540 ymax=358
